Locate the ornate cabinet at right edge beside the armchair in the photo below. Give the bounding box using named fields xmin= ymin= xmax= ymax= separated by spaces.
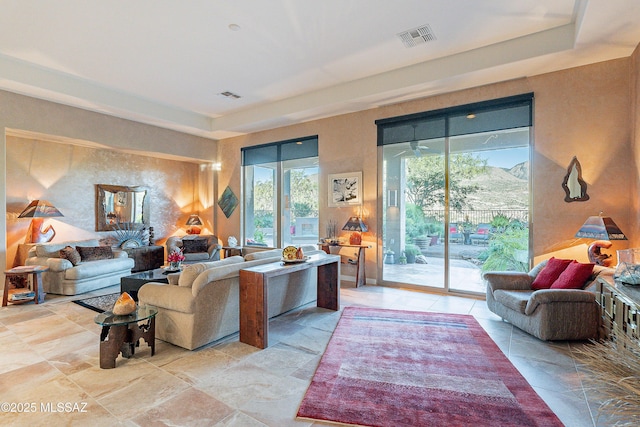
xmin=596 ymin=276 xmax=640 ymax=341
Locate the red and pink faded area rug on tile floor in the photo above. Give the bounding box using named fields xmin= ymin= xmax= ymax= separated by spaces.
xmin=298 ymin=307 xmax=562 ymax=427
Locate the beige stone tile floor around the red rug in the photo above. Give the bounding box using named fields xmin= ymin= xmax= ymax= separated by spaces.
xmin=0 ymin=286 xmax=607 ymax=427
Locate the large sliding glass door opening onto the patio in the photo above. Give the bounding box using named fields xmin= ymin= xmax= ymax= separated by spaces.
xmin=378 ymin=97 xmax=531 ymax=293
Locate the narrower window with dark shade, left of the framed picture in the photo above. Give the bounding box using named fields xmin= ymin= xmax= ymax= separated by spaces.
xmin=242 ymin=136 xmax=319 ymax=248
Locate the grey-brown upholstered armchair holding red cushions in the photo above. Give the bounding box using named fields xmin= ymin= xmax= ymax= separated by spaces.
xmin=483 ymin=260 xmax=614 ymax=341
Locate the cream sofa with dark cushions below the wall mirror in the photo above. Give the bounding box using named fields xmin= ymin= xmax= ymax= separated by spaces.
xmin=25 ymin=239 xmax=135 ymax=295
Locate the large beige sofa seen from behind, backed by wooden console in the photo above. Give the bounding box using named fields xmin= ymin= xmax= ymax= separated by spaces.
xmin=138 ymin=246 xmax=323 ymax=350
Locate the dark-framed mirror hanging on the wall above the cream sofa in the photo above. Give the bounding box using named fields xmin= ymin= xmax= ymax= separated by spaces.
xmin=96 ymin=184 xmax=149 ymax=231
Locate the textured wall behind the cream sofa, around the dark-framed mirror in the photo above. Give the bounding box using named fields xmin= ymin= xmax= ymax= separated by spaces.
xmin=6 ymin=136 xmax=202 ymax=268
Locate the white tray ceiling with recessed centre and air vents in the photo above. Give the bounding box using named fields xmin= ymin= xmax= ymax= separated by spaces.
xmin=0 ymin=0 xmax=640 ymax=139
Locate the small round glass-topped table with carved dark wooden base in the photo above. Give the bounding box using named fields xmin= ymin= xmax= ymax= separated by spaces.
xmin=94 ymin=305 xmax=158 ymax=369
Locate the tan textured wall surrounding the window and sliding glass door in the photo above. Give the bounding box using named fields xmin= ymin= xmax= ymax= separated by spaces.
xmin=218 ymin=55 xmax=638 ymax=278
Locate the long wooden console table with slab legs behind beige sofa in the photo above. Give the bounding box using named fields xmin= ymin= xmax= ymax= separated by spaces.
xmin=240 ymin=254 xmax=340 ymax=348
